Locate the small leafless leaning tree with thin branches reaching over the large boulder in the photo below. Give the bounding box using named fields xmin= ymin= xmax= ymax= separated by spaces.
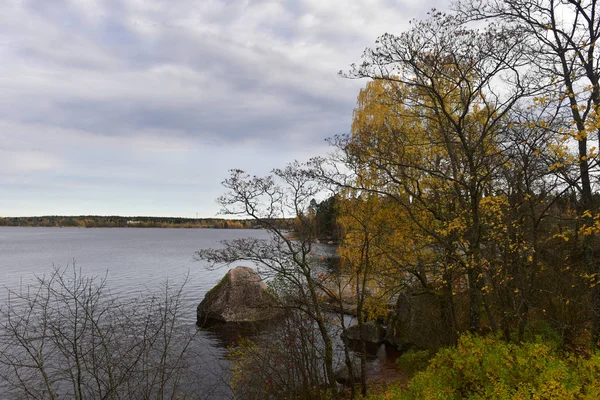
xmin=197 ymin=162 xmax=338 ymax=397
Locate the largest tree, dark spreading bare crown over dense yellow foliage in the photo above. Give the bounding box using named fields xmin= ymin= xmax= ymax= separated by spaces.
xmin=338 ymin=12 xmax=531 ymax=330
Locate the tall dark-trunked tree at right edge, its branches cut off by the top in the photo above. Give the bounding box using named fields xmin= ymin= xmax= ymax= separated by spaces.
xmin=455 ymin=0 xmax=600 ymax=346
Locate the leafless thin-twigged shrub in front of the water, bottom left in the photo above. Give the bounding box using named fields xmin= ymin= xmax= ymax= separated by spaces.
xmin=0 ymin=266 xmax=216 ymax=399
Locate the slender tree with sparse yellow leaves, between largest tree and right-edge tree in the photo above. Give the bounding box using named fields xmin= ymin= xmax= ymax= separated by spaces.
xmin=482 ymin=103 xmax=569 ymax=340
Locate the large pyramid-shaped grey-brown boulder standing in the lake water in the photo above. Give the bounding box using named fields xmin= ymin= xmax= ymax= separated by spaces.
xmin=197 ymin=267 xmax=282 ymax=325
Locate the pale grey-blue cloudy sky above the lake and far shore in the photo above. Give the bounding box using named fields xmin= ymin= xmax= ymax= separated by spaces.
xmin=0 ymin=0 xmax=445 ymax=218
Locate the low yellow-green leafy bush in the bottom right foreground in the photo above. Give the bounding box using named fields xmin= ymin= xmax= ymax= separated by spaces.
xmin=380 ymin=335 xmax=600 ymax=400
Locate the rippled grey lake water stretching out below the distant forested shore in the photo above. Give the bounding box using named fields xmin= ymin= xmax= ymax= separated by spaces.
xmin=0 ymin=227 xmax=404 ymax=398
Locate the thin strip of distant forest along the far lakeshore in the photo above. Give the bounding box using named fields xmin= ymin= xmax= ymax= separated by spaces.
xmin=0 ymin=215 xmax=293 ymax=229
